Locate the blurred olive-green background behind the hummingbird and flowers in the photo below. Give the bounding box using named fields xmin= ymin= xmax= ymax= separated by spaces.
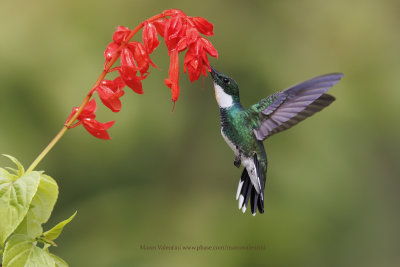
xmin=0 ymin=0 xmax=400 ymax=267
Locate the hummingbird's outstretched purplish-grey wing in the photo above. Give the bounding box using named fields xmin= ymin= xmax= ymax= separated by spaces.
xmin=246 ymin=73 xmax=343 ymax=141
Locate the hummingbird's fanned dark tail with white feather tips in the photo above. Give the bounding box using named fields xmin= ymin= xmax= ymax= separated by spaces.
xmin=236 ymin=168 xmax=264 ymax=216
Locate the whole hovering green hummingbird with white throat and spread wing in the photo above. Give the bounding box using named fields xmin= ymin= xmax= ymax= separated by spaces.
xmin=211 ymin=67 xmax=343 ymax=216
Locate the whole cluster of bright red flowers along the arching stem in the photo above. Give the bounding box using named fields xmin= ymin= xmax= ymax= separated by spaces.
xmin=66 ymin=9 xmax=218 ymax=139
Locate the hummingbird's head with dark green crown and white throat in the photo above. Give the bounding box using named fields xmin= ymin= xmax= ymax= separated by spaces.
xmin=210 ymin=66 xmax=240 ymax=108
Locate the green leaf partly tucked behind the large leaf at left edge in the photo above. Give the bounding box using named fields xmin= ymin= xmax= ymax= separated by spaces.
xmin=15 ymin=174 xmax=58 ymax=237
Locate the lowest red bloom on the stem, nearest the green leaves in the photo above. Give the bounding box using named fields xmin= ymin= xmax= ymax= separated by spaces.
xmin=65 ymin=99 xmax=115 ymax=140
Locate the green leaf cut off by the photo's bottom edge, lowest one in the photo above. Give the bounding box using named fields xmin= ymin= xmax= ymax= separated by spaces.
xmin=3 ymin=234 xmax=56 ymax=267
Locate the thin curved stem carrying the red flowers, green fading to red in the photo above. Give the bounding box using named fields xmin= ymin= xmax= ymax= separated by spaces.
xmin=26 ymin=14 xmax=167 ymax=173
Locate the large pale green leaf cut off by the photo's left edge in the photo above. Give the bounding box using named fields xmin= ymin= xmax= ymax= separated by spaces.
xmin=0 ymin=171 xmax=40 ymax=246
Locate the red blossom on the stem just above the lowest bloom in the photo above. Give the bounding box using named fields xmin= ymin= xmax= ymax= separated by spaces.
xmin=96 ymin=77 xmax=125 ymax=112
